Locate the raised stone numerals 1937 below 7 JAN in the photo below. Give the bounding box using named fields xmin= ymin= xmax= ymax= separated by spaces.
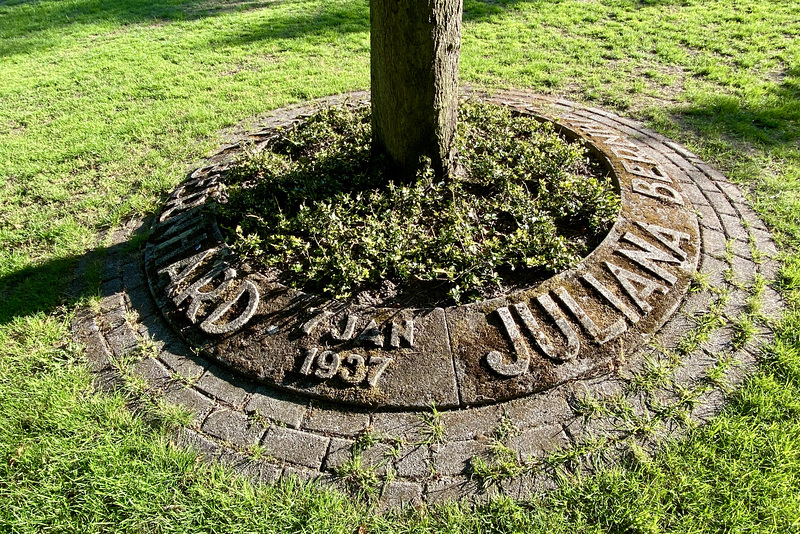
xmin=300 ymin=347 xmax=394 ymax=388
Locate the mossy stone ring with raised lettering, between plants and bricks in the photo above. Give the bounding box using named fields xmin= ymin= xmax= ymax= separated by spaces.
xmin=145 ymin=94 xmax=700 ymax=409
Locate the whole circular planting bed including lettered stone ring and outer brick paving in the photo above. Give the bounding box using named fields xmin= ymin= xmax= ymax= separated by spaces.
xmin=75 ymin=92 xmax=781 ymax=504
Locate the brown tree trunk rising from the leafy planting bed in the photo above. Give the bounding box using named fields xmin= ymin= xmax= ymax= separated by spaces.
xmin=370 ymin=0 xmax=463 ymax=183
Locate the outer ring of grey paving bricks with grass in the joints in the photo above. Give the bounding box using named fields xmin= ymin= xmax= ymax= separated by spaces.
xmin=73 ymin=92 xmax=783 ymax=506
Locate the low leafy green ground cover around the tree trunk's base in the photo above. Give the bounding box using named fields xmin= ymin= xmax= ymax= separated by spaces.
xmin=214 ymin=102 xmax=619 ymax=306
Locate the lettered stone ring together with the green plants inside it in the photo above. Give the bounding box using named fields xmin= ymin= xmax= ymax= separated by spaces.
xmin=145 ymin=92 xmax=700 ymax=408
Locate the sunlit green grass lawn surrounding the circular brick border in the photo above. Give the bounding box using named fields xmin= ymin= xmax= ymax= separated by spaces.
xmin=0 ymin=0 xmax=800 ymax=533
